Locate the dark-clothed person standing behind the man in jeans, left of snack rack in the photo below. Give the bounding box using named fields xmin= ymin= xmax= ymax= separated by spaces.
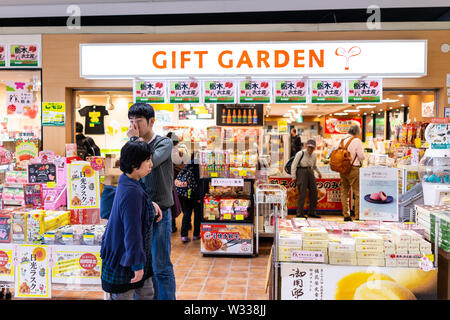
xmin=175 ymin=153 xmax=202 ymax=243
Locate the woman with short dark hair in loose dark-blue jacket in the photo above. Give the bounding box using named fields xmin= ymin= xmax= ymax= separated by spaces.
xmin=100 ymin=141 xmax=155 ymax=300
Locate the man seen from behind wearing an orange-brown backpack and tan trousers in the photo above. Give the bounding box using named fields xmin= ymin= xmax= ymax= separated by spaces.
xmin=339 ymin=125 xmax=364 ymax=221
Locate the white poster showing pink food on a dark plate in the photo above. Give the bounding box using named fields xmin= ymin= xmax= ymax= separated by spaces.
xmin=359 ymin=167 xmax=399 ymax=221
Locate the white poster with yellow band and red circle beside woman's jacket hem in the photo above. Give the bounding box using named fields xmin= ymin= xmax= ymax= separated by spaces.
xmin=52 ymin=246 xmax=102 ymax=284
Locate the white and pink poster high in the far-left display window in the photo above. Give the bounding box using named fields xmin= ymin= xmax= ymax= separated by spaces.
xmin=6 ymin=81 xmax=34 ymax=115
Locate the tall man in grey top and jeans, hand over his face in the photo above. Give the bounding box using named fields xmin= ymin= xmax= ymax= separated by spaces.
xmin=127 ymin=103 xmax=176 ymax=300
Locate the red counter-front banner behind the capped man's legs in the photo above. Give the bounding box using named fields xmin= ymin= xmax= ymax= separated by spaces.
xmin=269 ymin=177 xmax=342 ymax=211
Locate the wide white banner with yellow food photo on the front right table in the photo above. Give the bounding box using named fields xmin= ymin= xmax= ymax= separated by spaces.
xmin=281 ymin=263 xmax=437 ymax=300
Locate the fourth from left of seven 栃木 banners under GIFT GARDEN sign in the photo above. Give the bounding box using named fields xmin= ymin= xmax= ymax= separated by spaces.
xmin=239 ymin=80 xmax=272 ymax=103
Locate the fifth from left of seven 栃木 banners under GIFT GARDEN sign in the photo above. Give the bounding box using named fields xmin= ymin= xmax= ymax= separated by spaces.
xmin=275 ymin=80 xmax=308 ymax=103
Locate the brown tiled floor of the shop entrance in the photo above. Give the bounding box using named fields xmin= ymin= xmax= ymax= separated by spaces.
xmin=13 ymin=215 xmax=269 ymax=300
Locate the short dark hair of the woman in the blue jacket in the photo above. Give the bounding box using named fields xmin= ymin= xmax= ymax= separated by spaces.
xmin=120 ymin=141 xmax=153 ymax=174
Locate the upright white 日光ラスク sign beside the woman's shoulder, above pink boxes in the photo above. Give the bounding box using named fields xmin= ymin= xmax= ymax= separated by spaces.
xmin=67 ymin=162 xmax=100 ymax=209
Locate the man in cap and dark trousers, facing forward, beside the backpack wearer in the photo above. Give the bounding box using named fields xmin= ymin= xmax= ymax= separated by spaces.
xmin=291 ymin=139 xmax=322 ymax=218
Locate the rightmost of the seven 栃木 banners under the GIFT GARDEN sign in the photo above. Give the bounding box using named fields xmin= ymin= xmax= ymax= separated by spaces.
xmin=347 ymin=79 xmax=383 ymax=103
